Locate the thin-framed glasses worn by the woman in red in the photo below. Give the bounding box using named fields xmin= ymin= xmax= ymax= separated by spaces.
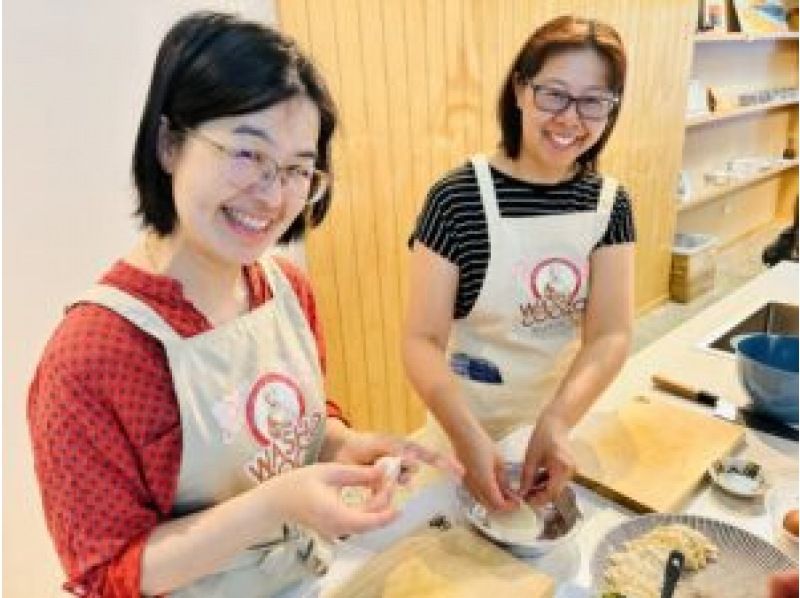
xmin=189 ymin=129 xmax=330 ymax=205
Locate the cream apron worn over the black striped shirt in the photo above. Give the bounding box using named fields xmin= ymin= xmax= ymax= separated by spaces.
xmin=428 ymin=156 xmax=617 ymax=440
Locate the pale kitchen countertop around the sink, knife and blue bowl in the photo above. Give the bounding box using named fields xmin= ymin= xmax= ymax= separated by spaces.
xmin=564 ymin=262 xmax=800 ymax=558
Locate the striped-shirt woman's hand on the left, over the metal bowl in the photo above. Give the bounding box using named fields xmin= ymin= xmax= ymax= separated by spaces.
xmin=453 ymin=430 xmax=519 ymax=511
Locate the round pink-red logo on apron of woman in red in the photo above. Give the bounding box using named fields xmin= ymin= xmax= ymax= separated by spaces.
xmin=245 ymin=372 xmax=306 ymax=446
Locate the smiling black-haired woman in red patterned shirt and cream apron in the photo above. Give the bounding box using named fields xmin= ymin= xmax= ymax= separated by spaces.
xmin=28 ymin=13 xmax=457 ymax=597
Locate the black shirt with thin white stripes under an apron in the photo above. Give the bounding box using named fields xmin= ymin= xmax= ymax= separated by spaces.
xmin=409 ymin=162 xmax=635 ymax=318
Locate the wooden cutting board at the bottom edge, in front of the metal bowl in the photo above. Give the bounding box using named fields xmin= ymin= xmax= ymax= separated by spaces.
xmin=330 ymin=526 xmax=555 ymax=598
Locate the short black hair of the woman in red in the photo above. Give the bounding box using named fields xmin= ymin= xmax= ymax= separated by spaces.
xmin=133 ymin=11 xmax=337 ymax=243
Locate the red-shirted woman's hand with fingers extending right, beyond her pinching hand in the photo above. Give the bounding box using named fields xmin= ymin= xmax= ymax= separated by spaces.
xmin=320 ymin=428 xmax=464 ymax=484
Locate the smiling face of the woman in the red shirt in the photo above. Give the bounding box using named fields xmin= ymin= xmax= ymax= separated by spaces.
xmin=152 ymin=97 xmax=327 ymax=272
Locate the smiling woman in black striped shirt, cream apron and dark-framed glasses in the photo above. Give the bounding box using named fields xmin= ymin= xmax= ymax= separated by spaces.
xmin=404 ymin=16 xmax=634 ymax=511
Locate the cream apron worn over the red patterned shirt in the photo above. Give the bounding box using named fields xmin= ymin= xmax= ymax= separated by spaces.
xmin=80 ymin=260 xmax=332 ymax=598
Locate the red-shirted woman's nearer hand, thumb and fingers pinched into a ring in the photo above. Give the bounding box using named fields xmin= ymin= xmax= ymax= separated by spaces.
xmin=264 ymin=463 xmax=397 ymax=539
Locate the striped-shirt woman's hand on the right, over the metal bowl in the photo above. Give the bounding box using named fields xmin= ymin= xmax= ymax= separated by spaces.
xmin=519 ymin=414 xmax=575 ymax=506
